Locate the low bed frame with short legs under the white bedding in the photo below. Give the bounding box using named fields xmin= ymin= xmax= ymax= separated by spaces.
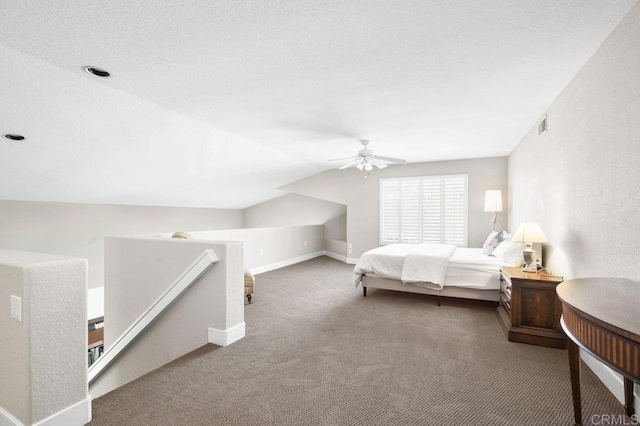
xmin=362 ymin=275 xmax=500 ymax=306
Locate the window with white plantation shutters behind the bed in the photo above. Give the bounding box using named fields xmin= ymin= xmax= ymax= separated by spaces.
xmin=380 ymin=175 xmax=468 ymax=247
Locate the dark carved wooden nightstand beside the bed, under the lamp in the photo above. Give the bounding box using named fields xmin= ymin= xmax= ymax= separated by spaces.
xmin=498 ymin=267 xmax=566 ymax=349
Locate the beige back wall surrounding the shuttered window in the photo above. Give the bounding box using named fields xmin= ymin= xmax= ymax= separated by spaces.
xmin=280 ymin=157 xmax=507 ymax=257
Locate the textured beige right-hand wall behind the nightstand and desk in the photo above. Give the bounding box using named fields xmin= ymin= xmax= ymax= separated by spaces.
xmin=509 ymin=1 xmax=640 ymax=280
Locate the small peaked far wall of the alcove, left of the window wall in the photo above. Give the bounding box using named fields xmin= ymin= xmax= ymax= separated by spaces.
xmin=243 ymin=194 xmax=347 ymax=240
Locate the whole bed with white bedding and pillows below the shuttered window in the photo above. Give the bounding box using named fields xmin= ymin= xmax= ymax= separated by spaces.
xmin=353 ymin=243 xmax=522 ymax=305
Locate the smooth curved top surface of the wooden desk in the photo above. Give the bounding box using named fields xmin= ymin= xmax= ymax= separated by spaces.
xmin=556 ymin=278 xmax=640 ymax=340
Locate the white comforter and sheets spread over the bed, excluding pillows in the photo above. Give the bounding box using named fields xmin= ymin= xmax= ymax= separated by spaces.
xmin=353 ymin=244 xmax=502 ymax=290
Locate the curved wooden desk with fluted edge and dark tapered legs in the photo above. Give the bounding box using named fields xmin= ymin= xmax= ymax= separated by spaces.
xmin=556 ymin=278 xmax=640 ymax=425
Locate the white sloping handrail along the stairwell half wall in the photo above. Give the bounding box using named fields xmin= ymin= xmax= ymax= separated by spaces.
xmin=89 ymin=249 xmax=218 ymax=384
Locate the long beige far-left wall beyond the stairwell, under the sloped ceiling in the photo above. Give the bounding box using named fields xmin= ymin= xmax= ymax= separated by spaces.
xmin=0 ymin=201 xmax=242 ymax=288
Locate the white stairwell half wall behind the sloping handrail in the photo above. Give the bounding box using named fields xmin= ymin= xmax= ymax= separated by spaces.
xmin=90 ymin=237 xmax=244 ymax=398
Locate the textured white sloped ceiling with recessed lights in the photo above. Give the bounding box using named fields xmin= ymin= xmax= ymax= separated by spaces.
xmin=0 ymin=0 xmax=635 ymax=207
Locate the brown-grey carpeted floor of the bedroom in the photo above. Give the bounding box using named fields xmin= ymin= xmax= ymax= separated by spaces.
xmin=91 ymin=257 xmax=630 ymax=426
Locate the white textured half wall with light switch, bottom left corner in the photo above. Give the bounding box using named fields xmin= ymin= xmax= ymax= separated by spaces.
xmin=0 ymin=249 xmax=91 ymax=425
